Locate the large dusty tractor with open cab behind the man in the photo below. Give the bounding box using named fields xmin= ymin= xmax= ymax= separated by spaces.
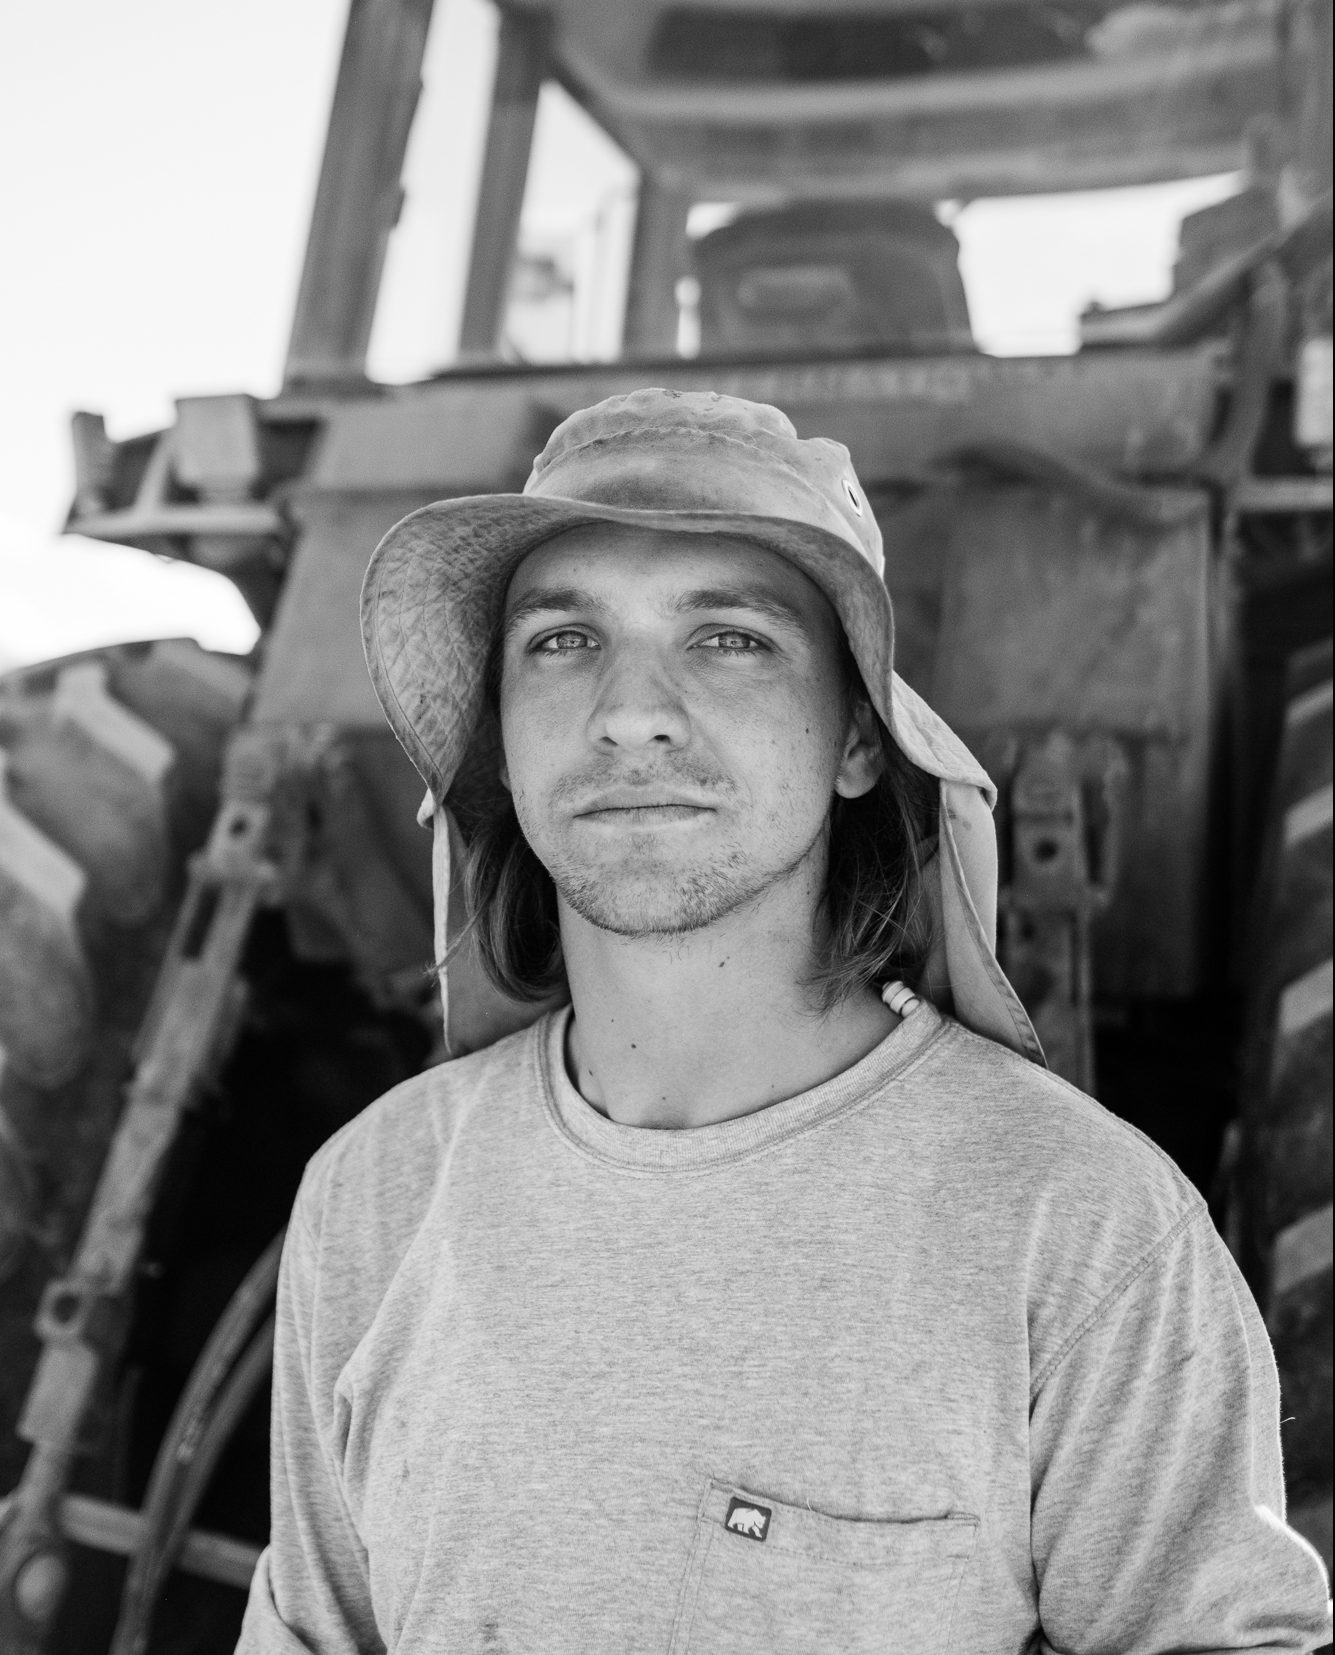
xmin=0 ymin=0 xmax=1332 ymax=1655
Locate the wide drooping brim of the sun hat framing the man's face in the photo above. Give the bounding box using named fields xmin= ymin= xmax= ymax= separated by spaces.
xmin=362 ymin=495 xmax=994 ymax=810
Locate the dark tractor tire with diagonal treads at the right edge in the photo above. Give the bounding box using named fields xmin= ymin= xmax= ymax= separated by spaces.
xmin=1239 ymin=640 xmax=1332 ymax=1569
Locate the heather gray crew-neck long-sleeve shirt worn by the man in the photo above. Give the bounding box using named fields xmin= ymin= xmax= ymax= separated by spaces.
xmin=240 ymin=1006 xmax=1330 ymax=1655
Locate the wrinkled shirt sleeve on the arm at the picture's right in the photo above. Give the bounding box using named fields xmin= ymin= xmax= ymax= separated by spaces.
xmin=1031 ymin=1206 xmax=1330 ymax=1655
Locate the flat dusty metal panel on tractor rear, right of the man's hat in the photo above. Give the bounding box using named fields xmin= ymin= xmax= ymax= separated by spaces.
xmin=882 ymin=488 xmax=1214 ymax=996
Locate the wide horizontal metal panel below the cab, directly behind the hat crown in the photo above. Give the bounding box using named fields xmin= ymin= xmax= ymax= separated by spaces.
xmin=297 ymin=348 xmax=1219 ymax=495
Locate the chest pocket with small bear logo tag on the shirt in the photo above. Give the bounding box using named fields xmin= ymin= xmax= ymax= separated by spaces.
xmin=670 ymin=1483 xmax=978 ymax=1655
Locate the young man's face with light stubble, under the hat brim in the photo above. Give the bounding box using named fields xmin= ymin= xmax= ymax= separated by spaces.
xmin=501 ymin=525 xmax=878 ymax=937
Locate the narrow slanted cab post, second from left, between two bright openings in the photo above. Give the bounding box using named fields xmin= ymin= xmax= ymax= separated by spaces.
xmin=458 ymin=12 xmax=548 ymax=357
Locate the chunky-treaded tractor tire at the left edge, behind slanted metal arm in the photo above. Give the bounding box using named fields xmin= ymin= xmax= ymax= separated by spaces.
xmin=0 ymin=640 xmax=251 ymax=1496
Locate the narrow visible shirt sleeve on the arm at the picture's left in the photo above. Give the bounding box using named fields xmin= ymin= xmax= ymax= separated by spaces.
xmin=237 ymin=1198 xmax=384 ymax=1655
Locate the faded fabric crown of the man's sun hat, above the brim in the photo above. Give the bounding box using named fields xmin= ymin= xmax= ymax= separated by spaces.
xmin=524 ymin=387 xmax=885 ymax=574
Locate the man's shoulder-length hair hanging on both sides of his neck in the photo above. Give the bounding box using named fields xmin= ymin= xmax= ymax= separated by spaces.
xmin=463 ymin=652 xmax=936 ymax=1011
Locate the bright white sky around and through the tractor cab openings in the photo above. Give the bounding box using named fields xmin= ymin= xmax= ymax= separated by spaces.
xmin=0 ymin=0 xmax=1231 ymax=670
